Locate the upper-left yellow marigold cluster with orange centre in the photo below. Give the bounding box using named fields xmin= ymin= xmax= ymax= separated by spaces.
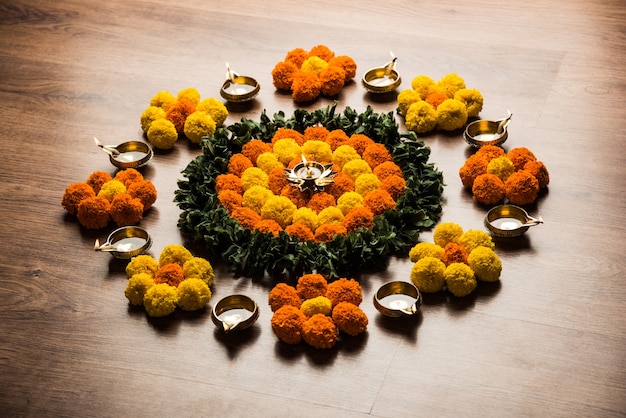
xmin=141 ymin=87 xmax=228 ymax=150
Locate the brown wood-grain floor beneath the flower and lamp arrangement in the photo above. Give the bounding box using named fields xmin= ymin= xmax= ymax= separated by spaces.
xmin=0 ymin=0 xmax=626 ymax=417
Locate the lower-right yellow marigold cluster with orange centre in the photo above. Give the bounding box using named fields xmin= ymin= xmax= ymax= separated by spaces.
xmin=409 ymin=222 xmax=502 ymax=297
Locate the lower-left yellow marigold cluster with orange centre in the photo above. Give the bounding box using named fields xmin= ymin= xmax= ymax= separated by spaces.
xmin=124 ymin=244 xmax=215 ymax=317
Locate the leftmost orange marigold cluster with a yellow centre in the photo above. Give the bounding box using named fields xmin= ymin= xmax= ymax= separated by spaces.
xmin=61 ymin=168 xmax=157 ymax=229
